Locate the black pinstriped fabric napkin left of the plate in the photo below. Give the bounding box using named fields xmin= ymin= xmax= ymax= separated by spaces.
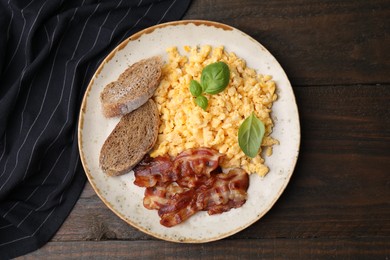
xmin=0 ymin=0 xmax=190 ymax=259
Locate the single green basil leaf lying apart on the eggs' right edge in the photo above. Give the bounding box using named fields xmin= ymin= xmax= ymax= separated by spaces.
xmin=238 ymin=112 xmax=265 ymax=158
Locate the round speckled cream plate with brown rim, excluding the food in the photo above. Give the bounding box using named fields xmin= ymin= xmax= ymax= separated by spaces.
xmin=78 ymin=20 xmax=300 ymax=243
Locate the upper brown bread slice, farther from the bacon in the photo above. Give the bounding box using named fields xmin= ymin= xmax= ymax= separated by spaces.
xmin=100 ymin=56 xmax=163 ymax=117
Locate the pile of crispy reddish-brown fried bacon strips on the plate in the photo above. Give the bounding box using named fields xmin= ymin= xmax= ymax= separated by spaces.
xmin=134 ymin=148 xmax=249 ymax=227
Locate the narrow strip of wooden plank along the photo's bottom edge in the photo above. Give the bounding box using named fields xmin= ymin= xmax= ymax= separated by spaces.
xmin=20 ymin=238 xmax=390 ymax=260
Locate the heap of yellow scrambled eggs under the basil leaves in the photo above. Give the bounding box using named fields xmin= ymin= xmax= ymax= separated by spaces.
xmin=151 ymin=45 xmax=278 ymax=176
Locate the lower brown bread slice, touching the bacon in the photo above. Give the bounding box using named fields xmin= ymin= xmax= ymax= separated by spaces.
xmin=99 ymin=99 xmax=160 ymax=176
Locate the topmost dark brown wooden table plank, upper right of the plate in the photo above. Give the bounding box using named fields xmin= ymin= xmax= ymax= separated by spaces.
xmin=184 ymin=0 xmax=390 ymax=85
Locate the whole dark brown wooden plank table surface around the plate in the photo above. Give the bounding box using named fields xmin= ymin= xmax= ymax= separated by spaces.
xmin=21 ymin=0 xmax=390 ymax=259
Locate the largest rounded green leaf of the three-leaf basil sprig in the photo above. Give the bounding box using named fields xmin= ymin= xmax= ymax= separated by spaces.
xmin=200 ymin=61 xmax=230 ymax=94
